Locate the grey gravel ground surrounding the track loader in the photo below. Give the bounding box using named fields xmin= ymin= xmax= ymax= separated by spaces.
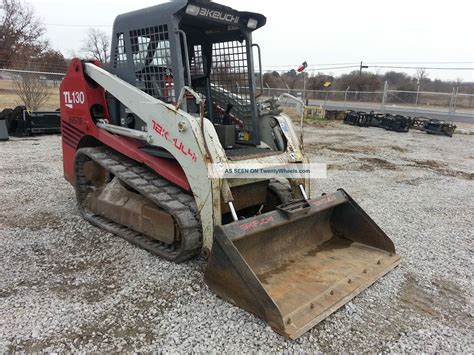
xmin=0 ymin=123 xmax=474 ymax=353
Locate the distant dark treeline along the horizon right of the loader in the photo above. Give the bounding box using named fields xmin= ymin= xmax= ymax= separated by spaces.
xmin=263 ymin=69 xmax=474 ymax=94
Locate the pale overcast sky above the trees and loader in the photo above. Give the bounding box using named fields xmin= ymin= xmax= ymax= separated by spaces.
xmin=27 ymin=0 xmax=474 ymax=82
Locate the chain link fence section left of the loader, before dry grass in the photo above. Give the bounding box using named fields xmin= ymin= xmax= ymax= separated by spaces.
xmin=0 ymin=68 xmax=65 ymax=111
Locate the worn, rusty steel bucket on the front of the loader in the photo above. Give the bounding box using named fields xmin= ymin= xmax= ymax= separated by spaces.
xmin=205 ymin=190 xmax=400 ymax=339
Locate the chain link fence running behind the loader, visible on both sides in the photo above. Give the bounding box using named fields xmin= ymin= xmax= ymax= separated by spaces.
xmin=0 ymin=68 xmax=474 ymax=114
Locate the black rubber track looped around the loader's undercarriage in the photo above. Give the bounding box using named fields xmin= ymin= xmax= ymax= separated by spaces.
xmin=75 ymin=147 xmax=202 ymax=262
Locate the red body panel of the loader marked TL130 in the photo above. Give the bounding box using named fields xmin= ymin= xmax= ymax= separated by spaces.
xmin=60 ymin=59 xmax=191 ymax=191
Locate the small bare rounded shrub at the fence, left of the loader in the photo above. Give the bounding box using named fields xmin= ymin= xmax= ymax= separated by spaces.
xmin=13 ymin=71 xmax=51 ymax=111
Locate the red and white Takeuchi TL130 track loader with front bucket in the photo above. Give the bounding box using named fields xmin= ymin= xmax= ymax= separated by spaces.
xmin=60 ymin=0 xmax=400 ymax=338
